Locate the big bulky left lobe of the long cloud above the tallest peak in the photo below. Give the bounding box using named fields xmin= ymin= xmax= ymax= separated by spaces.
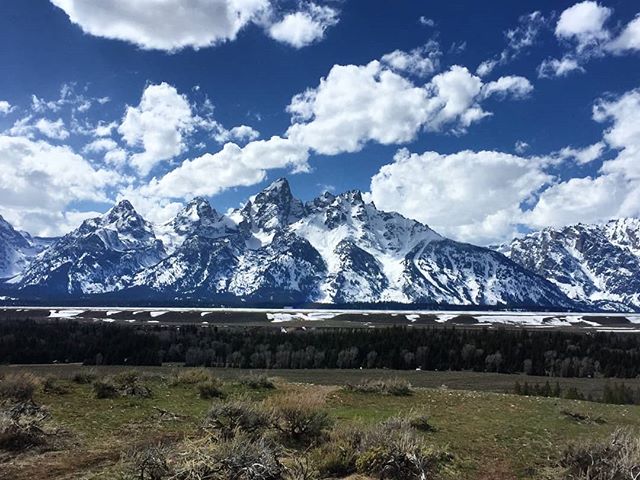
xmin=287 ymin=61 xmax=428 ymax=155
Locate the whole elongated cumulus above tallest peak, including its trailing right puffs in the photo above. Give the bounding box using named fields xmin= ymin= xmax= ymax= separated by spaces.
xmin=287 ymin=61 xmax=528 ymax=155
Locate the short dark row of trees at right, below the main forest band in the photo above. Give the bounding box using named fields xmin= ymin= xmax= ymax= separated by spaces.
xmin=513 ymin=381 xmax=640 ymax=405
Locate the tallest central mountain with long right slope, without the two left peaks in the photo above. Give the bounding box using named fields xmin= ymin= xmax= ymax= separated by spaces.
xmin=132 ymin=179 xmax=569 ymax=306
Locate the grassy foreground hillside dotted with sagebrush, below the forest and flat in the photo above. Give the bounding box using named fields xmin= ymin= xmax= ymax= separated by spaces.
xmin=0 ymin=366 xmax=640 ymax=480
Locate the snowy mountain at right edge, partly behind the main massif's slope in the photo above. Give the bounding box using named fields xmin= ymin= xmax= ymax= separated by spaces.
xmin=499 ymin=218 xmax=640 ymax=310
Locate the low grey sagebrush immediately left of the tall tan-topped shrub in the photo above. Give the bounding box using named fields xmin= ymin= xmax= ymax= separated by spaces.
xmin=205 ymin=400 xmax=270 ymax=440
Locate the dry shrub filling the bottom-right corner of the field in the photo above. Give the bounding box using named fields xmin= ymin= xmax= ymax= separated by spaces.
xmin=560 ymin=429 xmax=640 ymax=480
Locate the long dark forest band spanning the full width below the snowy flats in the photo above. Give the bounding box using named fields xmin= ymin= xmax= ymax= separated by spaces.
xmin=0 ymin=320 xmax=640 ymax=378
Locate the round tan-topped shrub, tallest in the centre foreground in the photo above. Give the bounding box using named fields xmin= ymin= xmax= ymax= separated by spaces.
xmin=272 ymin=392 xmax=332 ymax=443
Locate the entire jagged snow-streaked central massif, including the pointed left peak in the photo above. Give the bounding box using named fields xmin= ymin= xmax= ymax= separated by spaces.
xmin=0 ymin=179 xmax=584 ymax=308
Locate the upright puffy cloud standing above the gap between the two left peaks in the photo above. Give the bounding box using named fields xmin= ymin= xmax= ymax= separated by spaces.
xmin=118 ymin=82 xmax=195 ymax=175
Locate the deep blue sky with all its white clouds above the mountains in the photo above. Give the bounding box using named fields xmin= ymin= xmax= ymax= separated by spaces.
xmin=0 ymin=0 xmax=640 ymax=245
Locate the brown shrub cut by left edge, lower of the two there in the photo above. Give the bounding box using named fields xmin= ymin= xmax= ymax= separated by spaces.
xmin=0 ymin=401 xmax=48 ymax=451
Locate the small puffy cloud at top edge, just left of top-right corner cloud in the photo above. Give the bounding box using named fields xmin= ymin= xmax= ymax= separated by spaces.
xmin=555 ymin=0 xmax=612 ymax=52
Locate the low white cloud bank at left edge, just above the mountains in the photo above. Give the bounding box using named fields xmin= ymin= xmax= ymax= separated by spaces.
xmin=0 ymin=135 xmax=121 ymax=235
